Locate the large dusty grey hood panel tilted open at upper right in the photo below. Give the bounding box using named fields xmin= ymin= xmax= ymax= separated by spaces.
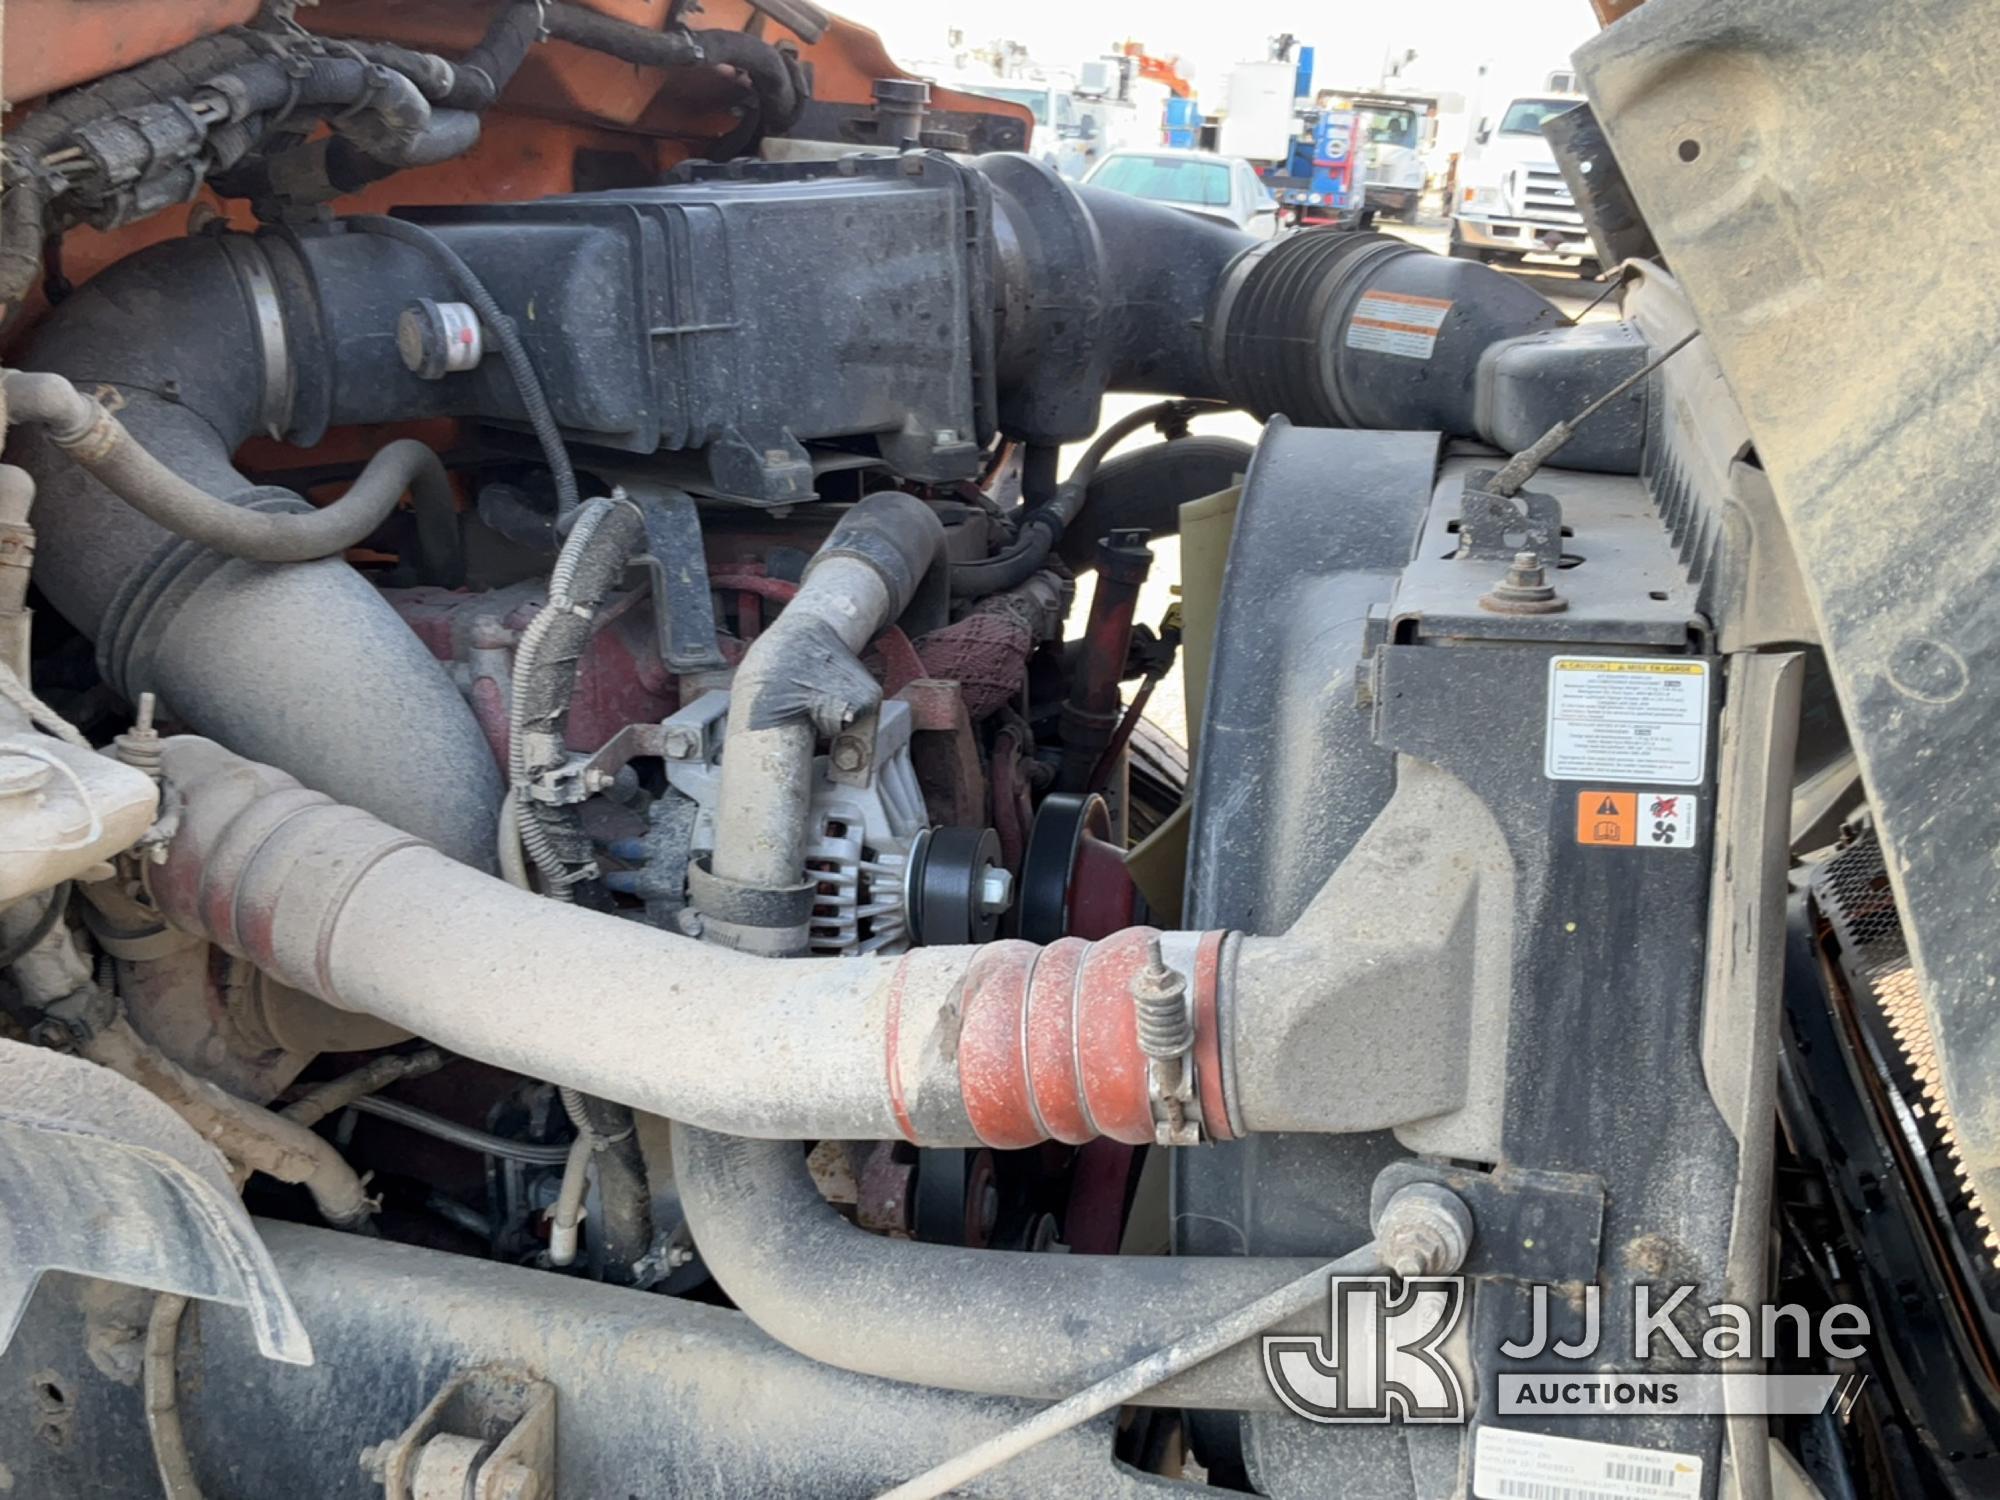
xmin=1578 ymin=0 xmax=2000 ymax=1240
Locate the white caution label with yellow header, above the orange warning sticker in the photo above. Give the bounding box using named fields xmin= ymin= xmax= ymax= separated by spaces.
xmin=1542 ymin=656 xmax=1708 ymax=786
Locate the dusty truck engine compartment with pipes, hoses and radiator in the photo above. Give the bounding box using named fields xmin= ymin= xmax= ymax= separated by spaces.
xmin=0 ymin=0 xmax=1990 ymax=1500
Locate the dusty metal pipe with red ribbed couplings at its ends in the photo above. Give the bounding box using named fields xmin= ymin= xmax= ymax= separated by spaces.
xmin=148 ymin=736 xmax=1234 ymax=1148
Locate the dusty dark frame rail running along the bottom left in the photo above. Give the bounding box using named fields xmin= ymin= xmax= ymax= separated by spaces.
xmin=0 ymin=1220 xmax=1186 ymax=1500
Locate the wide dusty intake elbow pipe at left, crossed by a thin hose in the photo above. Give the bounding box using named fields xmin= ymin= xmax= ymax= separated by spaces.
xmin=10 ymin=236 xmax=502 ymax=868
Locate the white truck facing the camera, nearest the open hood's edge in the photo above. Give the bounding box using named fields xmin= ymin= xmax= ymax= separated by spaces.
xmin=1452 ymin=94 xmax=1598 ymax=276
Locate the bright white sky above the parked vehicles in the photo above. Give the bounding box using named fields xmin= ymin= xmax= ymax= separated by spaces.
xmin=834 ymin=0 xmax=1598 ymax=100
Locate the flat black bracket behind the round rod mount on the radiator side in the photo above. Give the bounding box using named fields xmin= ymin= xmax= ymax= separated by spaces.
xmin=1368 ymin=1160 xmax=1604 ymax=1286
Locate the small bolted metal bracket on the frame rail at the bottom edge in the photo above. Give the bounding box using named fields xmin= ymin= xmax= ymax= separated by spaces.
xmin=362 ymin=1364 xmax=556 ymax=1500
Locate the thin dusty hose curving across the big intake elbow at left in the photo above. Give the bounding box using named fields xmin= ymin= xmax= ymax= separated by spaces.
xmin=0 ymin=370 xmax=464 ymax=568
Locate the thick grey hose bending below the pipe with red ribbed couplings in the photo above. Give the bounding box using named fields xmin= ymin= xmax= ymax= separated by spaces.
xmin=674 ymin=1122 xmax=1326 ymax=1410
